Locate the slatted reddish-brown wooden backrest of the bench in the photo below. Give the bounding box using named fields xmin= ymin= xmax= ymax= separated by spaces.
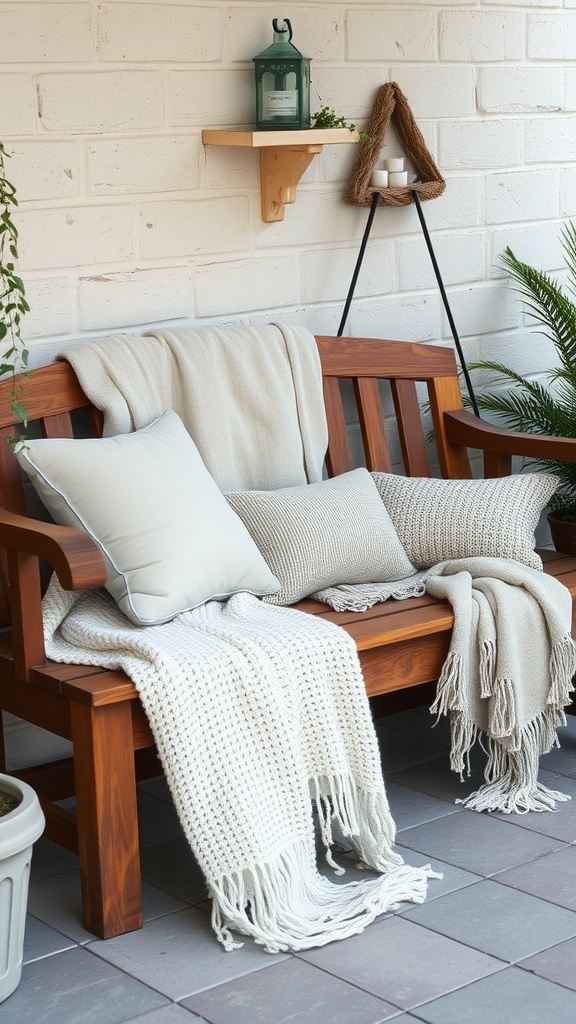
xmin=0 ymin=336 xmax=471 ymax=625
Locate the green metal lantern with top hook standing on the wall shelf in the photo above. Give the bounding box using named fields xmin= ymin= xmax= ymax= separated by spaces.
xmin=253 ymin=17 xmax=311 ymax=129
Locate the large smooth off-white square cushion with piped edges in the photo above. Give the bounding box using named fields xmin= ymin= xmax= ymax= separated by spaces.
xmin=16 ymin=412 xmax=280 ymax=625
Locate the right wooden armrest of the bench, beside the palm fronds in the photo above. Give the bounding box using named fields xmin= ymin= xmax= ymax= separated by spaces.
xmin=444 ymin=409 xmax=576 ymax=476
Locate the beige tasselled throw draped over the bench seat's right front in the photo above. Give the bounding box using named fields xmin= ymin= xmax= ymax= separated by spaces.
xmin=316 ymin=558 xmax=576 ymax=813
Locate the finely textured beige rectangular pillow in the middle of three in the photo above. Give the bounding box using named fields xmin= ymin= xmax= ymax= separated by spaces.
xmin=225 ymin=469 xmax=414 ymax=604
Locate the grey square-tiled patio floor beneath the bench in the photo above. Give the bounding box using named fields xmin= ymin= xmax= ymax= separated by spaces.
xmin=6 ymin=709 xmax=576 ymax=1024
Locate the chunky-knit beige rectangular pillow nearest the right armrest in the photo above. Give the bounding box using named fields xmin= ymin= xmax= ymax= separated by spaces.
xmin=372 ymin=473 xmax=560 ymax=569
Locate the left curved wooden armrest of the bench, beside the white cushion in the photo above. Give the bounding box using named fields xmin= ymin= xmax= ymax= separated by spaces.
xmin=0 ymin=508 xmax=107 ymax=590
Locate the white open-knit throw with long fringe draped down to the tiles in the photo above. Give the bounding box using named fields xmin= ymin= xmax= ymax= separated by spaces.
xmin=44 ymin=577 xmax=438 ymax=952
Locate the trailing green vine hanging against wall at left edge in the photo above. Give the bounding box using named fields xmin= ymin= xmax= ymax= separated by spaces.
xmin=0 ymin=142 xmax=30 ymax=427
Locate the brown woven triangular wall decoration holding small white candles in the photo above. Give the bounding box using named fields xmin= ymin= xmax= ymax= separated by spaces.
xmin=344 ymin=82 xmax=446 ymax=206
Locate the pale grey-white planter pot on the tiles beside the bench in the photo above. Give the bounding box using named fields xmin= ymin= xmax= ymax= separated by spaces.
xmin=0 ymin=775 xmax=44 ymax=1002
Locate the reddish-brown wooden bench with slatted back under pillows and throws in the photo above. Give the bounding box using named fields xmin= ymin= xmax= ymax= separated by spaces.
xmin=0 ymin=337 xmax=576 ymax=938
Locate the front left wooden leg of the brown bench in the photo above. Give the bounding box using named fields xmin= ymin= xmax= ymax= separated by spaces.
xmin=72 ymin=700 xmax=142 ymax=939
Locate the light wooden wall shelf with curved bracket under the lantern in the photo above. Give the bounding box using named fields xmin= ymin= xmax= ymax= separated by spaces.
xmin=202 ymin=128 xmax=359 ymax=221
